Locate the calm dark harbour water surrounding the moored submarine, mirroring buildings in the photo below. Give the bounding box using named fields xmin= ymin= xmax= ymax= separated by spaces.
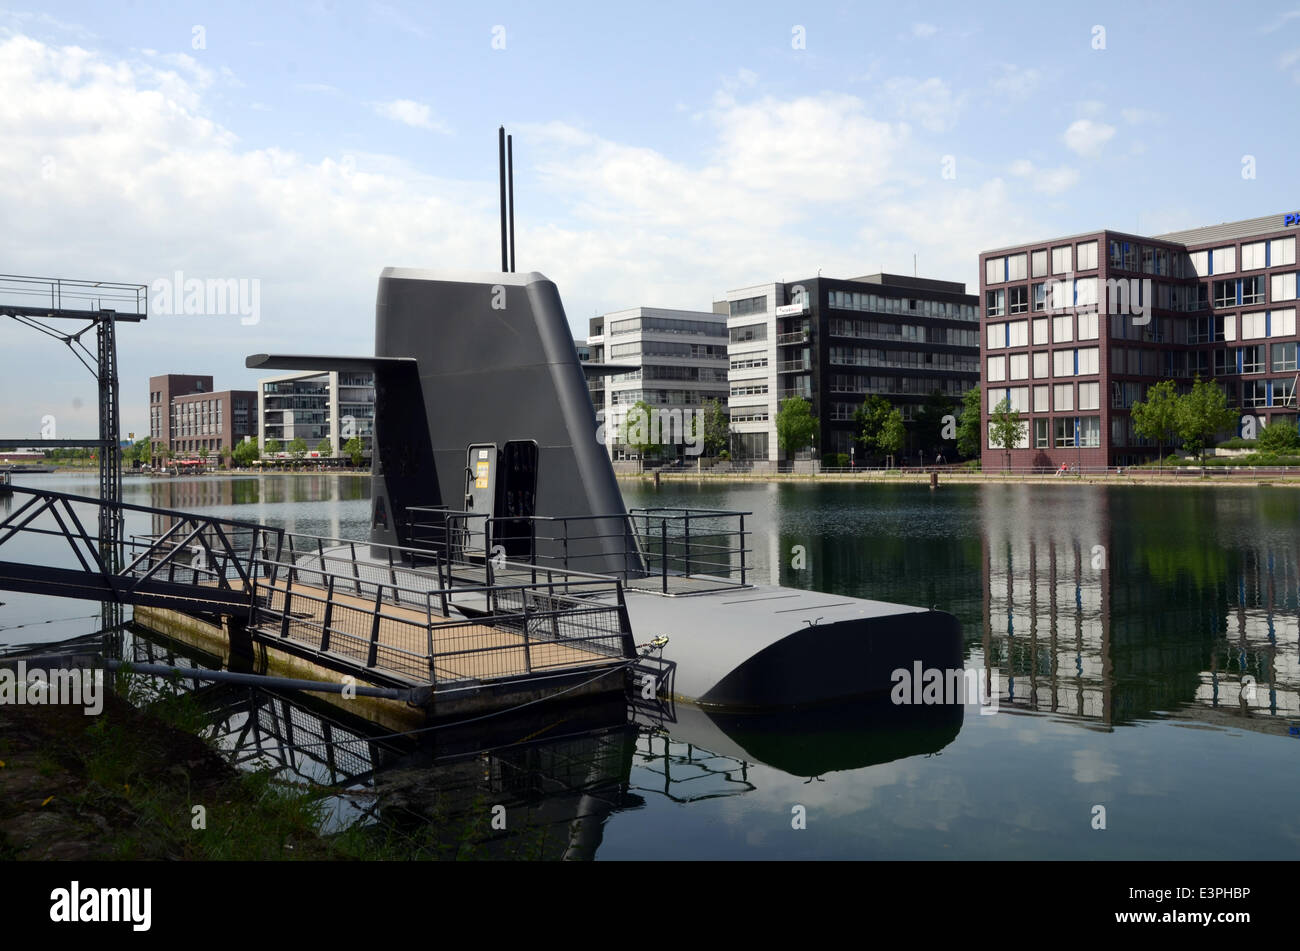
xmin=0 ymin=476 xmax=1300 ymax=859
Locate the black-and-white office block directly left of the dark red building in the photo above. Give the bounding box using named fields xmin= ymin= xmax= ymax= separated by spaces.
xmin=714 ymin=274 xmax=979 ymax=464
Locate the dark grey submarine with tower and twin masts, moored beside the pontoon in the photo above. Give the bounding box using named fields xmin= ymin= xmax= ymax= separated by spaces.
xmin=246 ymin=129 xmax=962 ymax=711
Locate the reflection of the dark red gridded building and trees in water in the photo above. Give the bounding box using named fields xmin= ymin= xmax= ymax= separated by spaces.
xmin=982 ymin=487 xmax=1300 ymax=733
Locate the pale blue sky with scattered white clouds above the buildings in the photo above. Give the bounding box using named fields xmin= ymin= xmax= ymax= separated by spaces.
xmin=0 ymin=0 xmax=1300 ymax=438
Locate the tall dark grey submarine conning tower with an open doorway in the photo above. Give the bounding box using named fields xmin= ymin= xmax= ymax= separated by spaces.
xmin=371 ymin=268 xmax=640 ymax=574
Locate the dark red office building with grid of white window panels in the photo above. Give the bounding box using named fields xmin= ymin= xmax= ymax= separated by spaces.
xmin=979 ymin=214 xmax=1300 ymax=469
